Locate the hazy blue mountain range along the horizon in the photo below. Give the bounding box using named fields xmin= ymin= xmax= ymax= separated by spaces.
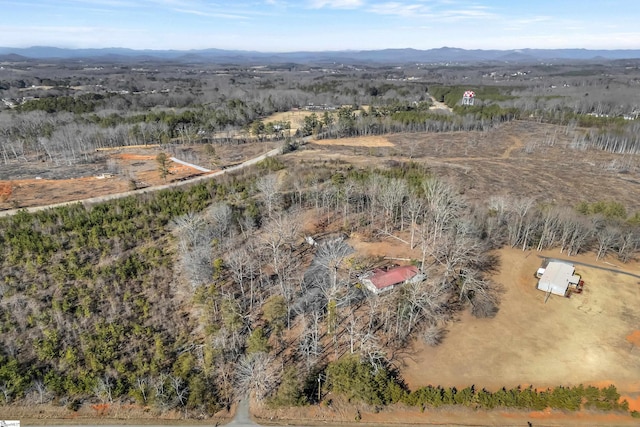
xmin=0 ymin=46 xmax=640 ymax=64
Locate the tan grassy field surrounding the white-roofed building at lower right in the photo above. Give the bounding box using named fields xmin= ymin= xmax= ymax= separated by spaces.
xmin=402 ymin=249 xmax=640 ymax=395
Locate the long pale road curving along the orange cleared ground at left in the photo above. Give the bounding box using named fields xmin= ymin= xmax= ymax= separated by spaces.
xmin=0 ymin=148 xmax=282 ymax=221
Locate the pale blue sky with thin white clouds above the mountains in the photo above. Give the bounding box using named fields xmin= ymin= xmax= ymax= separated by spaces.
xmin=0 ymin=0 xmax=640 ymax=52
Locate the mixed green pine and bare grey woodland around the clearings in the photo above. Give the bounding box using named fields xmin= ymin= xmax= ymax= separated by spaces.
xmin=0 ymin=59 xmax=640 ymax=416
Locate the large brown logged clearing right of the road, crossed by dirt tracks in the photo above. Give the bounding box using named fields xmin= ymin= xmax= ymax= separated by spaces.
xmin=292 ymin=121 xmax=640 ymax=214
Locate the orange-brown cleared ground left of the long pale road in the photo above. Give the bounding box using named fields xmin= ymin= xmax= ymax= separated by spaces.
xmin=0 ymin=142 xmax=278 ymax=210
